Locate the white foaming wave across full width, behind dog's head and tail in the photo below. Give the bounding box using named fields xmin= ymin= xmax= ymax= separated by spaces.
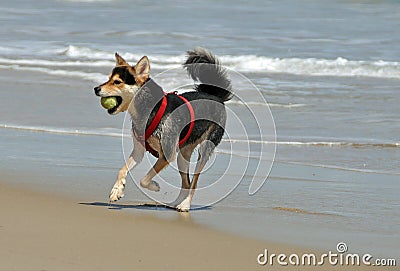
xmin=0 ymin=45 xmax=400 ymax=79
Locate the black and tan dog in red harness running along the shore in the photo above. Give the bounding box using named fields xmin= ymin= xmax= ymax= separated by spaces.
xmin=94 ymin=47 xmax=233 ymax=212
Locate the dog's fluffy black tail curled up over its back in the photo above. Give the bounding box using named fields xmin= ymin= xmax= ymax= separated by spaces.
xmin=183 ymin=47 xmax=233 ymax=102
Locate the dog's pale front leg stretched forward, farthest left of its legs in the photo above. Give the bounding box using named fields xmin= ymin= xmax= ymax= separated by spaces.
xmin=110 ymin=139 xmax=145 ymax=202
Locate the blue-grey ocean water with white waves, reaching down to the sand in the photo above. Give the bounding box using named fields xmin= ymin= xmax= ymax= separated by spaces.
xmin=0 ymin=0 xmax=400 ymax=256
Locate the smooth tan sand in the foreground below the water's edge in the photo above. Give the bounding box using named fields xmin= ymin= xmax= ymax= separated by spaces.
xmin=0 ymin=184 xmax=394 ymax=271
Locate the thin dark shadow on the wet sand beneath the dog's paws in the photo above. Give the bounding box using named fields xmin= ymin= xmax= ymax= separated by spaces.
xmin=79 ymin=202 xmax=211 ymax=212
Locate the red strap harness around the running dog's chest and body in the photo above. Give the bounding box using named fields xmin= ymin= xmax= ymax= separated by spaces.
xmin=133 ymin=92 xmax=194 ymax=157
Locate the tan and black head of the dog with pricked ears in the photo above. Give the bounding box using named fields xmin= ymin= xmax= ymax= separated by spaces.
xmin=94 ymin=53 xmax=150 ymax=115
